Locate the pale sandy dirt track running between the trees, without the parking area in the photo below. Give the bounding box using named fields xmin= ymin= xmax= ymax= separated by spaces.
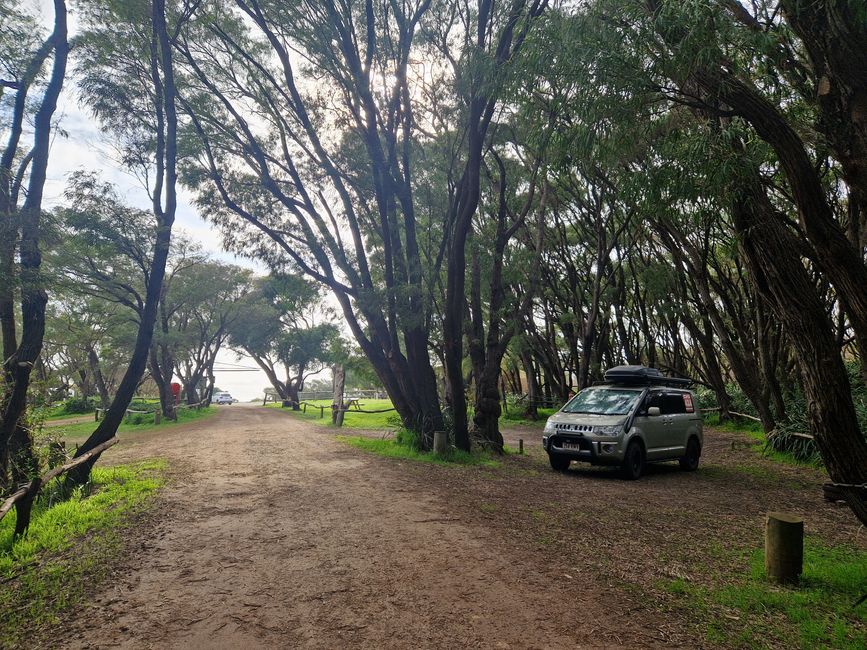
xmin=52 ymin=405 xmax=659 ymax=650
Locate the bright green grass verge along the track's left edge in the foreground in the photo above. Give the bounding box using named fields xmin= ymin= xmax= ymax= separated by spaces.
xmin=0 ymin=460 xmax=167 ymax=647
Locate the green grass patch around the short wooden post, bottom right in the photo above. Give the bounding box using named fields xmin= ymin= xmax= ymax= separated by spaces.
xmin=664 ymin=537 xmax=867 ymax=650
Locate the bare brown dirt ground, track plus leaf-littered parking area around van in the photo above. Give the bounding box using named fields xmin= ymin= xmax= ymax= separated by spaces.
xmin=50 ymin=405 xmax=857 ymax=650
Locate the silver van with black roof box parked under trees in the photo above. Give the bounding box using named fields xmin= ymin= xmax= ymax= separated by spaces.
xmin=542 ymin=366 xmax=703 ymax=480
